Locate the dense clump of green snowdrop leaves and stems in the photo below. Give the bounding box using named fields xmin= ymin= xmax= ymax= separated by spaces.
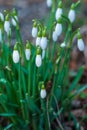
xmin=0 ymin=0 xmax=87 ymax=130
